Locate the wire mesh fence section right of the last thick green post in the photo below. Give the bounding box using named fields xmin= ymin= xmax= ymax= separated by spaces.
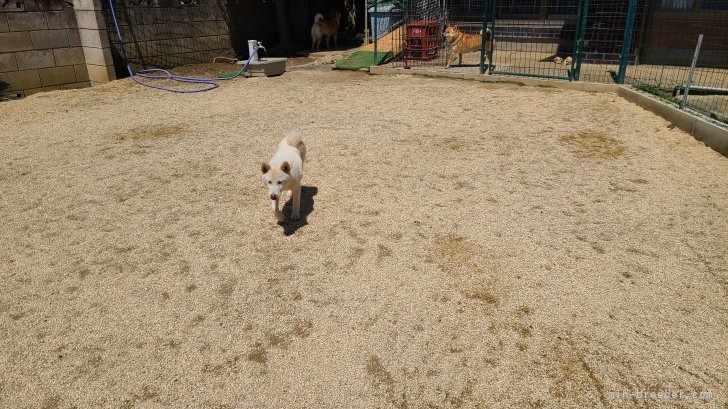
xmin=625 ymin=0 xmax=728 ymax=123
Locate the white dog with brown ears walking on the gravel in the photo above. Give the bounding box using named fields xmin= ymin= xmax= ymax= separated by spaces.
xmin=260 ymin=130 xmax=306 ymax=222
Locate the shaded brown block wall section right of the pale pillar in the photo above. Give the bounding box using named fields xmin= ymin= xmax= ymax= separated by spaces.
xmin=106 ymin=0 xmax=235 ymax=73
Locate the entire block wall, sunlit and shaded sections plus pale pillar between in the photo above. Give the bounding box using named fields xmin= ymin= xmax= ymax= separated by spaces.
xmin=0 ymin=0 xmax=235 ymax=96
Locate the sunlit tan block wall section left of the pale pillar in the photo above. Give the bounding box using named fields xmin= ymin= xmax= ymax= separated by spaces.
xmin=0 ymin=7 xmax=90 ymax=96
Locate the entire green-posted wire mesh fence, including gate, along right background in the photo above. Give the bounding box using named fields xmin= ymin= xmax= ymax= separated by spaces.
xmin=383 ymin=0 xmax=728 ymax=123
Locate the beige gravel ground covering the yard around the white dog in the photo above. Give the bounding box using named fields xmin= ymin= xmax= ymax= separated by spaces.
xmin=0 ymin=71 xmax=728 ymax=408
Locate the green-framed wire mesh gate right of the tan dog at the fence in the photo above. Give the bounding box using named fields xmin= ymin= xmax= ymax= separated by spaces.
xmin=480 ymin=0 xmax=640 ymax=83
